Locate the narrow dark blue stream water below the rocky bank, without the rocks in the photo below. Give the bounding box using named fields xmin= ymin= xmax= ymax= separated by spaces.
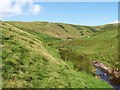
xmin=96 ymin=68 xmax=120 ymax=90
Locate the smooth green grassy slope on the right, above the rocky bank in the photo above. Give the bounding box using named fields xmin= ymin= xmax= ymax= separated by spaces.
xmin=60 ymin=27 xmax=120 ymax=69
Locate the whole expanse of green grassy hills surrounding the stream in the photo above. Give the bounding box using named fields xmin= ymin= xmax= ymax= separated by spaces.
xmin=0 ymin=21 xmax=117 ymax=88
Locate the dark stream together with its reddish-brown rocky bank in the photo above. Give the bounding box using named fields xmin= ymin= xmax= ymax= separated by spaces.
xmin=93 ymin=61 xmax=120 ymax=90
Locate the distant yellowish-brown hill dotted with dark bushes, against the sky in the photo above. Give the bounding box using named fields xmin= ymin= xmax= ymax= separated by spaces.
xmin=8 ymin=22 xmax=93 ymax=39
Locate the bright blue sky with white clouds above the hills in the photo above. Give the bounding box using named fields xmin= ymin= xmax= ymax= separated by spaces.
xmin=0 ymin=0 xmax=118 ymax=26
